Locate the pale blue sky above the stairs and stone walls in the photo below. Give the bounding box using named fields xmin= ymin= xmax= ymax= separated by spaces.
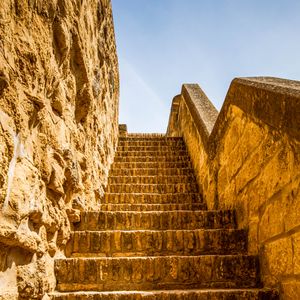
xmin=112 ymin=0 xmax=300 ymax=132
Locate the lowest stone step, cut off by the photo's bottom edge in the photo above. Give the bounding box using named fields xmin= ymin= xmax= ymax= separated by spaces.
xmin=51 ymin=289 xmax=279 ymax=300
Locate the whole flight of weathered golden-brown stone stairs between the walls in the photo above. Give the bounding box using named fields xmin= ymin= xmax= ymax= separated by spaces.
xmin=52 ymin=134 xmax=279 ymax=300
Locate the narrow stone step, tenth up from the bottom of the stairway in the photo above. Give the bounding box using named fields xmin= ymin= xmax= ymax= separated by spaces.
xmin=111 ymin=161 xmax=191 ymax=170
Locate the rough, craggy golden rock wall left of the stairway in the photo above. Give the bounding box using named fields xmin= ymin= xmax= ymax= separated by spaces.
xmin=0 ymin=0 xmax=119 ymax=299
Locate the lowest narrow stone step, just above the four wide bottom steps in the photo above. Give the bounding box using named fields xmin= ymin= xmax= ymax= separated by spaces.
xmin=99 ymin=203 xmax=207 ymax=211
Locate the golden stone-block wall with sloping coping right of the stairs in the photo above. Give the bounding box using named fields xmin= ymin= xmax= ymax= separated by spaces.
xmin=168 ymin=78 xmax=300 ymax=300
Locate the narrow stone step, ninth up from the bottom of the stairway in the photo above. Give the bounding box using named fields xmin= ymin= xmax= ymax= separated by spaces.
xmin=109 ymin=167 xmax=194 ymax=176
